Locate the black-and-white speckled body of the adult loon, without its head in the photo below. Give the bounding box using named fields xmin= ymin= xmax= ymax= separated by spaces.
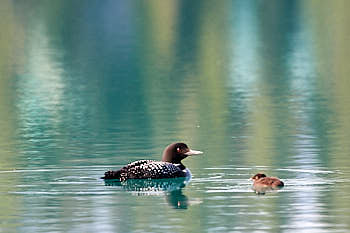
xmin=104 ymin=160 xmax=188 ymax=181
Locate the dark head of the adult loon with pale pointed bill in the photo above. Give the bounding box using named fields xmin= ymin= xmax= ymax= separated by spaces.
xmin=162 ymin=142 xmax=203 ymax=164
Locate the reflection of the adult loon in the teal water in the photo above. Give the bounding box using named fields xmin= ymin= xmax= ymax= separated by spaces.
xmin=105 ymin=177 xmax=190 ymax=209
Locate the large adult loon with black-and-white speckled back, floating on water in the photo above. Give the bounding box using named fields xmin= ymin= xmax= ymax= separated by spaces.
xmin=101 ymin=143 xmax=203 ymax=181
